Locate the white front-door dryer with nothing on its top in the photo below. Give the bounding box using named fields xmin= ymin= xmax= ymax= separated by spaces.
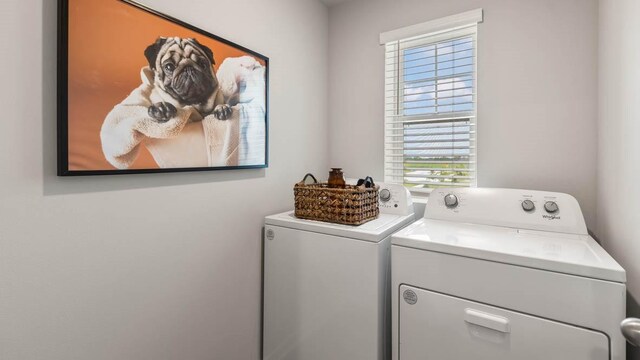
xmin=392 ymin=189 xmax=626 ymax=360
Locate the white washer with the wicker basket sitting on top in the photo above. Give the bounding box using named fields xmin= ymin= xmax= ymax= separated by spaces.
xmin=263 ymin=184 xmax=415 ymax=360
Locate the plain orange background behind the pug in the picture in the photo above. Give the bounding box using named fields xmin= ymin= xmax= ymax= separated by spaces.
xmin=68 ymin=0 xmax=264 ymax=170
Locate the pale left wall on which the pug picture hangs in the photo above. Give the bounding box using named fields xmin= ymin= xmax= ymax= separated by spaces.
xmin=0 ymin=0 xmax=328 ymax=360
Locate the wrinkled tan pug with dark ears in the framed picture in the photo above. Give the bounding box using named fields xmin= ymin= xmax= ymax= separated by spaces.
xmin=144 ymin=37 xmax=232 ymax=123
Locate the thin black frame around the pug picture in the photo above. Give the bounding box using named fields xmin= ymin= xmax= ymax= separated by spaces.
xmin=57 ymin=0 xmax=269 ymax=177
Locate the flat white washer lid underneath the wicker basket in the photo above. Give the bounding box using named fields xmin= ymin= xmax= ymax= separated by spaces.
xmin=265 ymin=211 xmax=415 ymax=242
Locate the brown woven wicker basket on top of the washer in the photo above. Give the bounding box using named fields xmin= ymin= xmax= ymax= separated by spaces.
xmin=293 ymin=174 xmax=380 ymax=225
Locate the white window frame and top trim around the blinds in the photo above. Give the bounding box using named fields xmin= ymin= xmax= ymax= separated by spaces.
xmin=380 ymin=9 xmax=483 ymax=197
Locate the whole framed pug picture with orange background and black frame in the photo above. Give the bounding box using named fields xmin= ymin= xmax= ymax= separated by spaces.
xmin=58 ymin=0 xmax=269 ymax=176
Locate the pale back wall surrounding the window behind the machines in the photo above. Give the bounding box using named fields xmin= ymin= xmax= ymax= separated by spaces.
xmin=329 ymin=0 xmax=598 ymax=227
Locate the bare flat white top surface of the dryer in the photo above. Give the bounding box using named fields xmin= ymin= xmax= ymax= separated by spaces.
xmin=392 ymin=219 xmax=626 ymax=283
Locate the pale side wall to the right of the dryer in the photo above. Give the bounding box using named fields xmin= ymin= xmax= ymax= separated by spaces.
xmin=596 ymin=0 xmax=640 ymax=359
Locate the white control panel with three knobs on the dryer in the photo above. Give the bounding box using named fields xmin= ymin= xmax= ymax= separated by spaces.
xmin=424 ymin=188 xmax=587 ymax=235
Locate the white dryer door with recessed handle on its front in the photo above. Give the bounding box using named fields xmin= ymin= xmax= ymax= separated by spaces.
xmin=398 ymin=285 xmax=609 ymax=360
